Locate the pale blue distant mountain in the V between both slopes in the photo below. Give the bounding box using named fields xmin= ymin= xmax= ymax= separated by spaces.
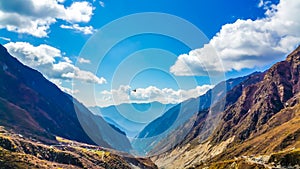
xmin=89 ymin=102 xmax=174 ymax=137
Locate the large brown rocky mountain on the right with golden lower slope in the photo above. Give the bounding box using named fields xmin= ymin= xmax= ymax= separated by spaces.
xmin=153 ymin=47 xmax=300 ymax=168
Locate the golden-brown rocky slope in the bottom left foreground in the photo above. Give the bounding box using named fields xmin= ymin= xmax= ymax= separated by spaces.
xmin=0 ymin=126 xmax=157 ymax=169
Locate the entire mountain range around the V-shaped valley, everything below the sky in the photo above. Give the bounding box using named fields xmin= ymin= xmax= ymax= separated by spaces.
xmin=0 ymin=43 xmax=300 ymax=169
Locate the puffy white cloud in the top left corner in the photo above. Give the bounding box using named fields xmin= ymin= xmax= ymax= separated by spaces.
xmin=0 ymin=0 xmax=94 ymax=37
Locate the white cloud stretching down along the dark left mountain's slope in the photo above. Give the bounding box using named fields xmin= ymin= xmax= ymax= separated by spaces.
xmin=4 ymin=42 xmax=106 ymax=84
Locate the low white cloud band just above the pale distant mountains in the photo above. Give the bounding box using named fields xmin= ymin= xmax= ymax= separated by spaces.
xmin=100 ymin=85 xmax=213 ymax=106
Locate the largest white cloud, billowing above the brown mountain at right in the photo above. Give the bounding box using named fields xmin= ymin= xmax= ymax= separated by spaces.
xmin=170 ymin=0 xmax=300 ymax=76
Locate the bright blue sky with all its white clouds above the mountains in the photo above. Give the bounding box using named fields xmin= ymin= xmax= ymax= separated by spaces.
xmin=0 ymin=0 xmax=300 ymax=107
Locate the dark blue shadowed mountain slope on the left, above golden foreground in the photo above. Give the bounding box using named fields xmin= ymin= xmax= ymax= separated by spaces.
xmin=0 ymin=45 xmax=130 ymax=151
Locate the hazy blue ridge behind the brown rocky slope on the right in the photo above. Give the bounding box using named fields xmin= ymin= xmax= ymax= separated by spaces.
xmin=133 ymin=72 xmax=253 ymax=155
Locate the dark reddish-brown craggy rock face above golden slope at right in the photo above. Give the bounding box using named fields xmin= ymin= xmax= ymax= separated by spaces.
xmin=213 ymin=48 xmax=300 ymax=143
